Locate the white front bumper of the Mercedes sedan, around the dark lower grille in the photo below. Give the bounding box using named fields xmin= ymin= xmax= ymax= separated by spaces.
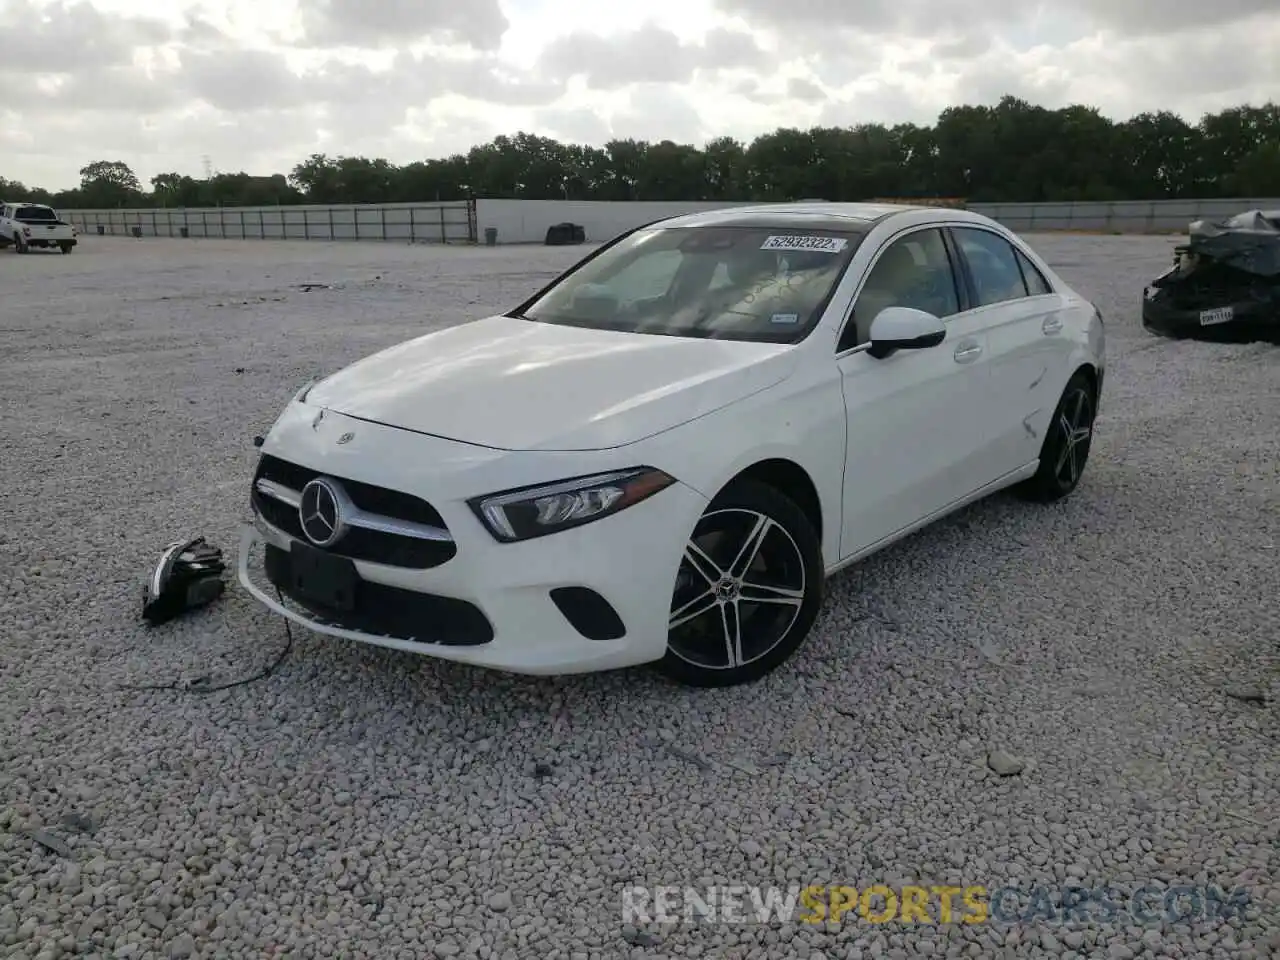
xmin=238 ymin=415 xmax=707 ymax=675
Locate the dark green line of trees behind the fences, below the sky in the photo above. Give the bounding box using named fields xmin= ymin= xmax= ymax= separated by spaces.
xmin=0 ymin=96 xmax=1280 ymax=209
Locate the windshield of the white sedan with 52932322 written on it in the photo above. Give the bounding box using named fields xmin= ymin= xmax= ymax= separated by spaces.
xmin=520 ymin=225 xmax=865 ymax=343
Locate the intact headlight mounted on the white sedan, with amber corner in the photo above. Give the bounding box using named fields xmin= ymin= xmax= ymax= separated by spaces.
xmin=468 ymin=467 xmax=676 ymax=543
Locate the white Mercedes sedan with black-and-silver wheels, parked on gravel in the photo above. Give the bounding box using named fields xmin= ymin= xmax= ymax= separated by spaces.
xmin=239 ymin=204 xmax=1105 ymax=686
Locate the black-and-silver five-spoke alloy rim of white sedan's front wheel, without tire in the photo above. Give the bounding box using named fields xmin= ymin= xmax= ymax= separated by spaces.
xmin=668 ymin=507 xmax=808 ymax=669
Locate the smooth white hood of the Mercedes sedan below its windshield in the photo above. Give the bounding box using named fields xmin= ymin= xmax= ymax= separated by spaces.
xmin=306 ymin=316 xmax=795 ymax=451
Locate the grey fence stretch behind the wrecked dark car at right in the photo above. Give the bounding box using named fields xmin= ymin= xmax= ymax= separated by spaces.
xmin=968 ymin=197 xmax=1280 ymax=233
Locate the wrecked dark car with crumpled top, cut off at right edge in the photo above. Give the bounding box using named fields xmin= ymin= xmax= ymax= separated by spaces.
xmin=1142 ymin=210 xmax=1280 ymax=339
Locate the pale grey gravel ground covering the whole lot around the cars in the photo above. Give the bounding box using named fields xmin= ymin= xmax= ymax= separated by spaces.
xmin=0 ymin=237 xmax=1280 ymax=960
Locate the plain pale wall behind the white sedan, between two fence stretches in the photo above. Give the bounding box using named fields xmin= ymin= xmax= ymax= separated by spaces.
xmin=476 ymin=200 xmax=746 ymax=243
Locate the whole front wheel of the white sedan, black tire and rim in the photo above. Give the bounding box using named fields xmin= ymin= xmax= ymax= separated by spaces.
xmin=657 ymin=480 xmax=824 ymax=687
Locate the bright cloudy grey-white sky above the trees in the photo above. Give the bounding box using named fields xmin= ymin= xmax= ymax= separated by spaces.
xmin=0 ymin=0 xmax=1280 ymax=188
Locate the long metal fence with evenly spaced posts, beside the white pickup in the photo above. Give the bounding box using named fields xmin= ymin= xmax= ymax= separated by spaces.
xmin=63 ymin=200 xmax=476 ymax=243
